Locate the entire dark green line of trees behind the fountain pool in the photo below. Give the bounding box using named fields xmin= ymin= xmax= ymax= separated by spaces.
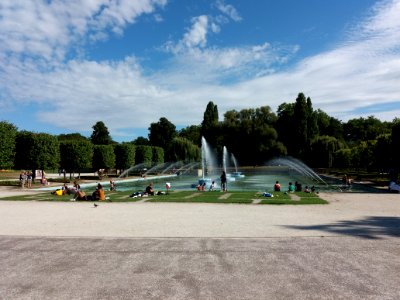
xmin=0 ymin=93 xmax=400 ymax=173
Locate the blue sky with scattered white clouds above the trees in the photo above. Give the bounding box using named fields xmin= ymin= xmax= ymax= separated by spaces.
xmin=0 ymin=0 xmax=400 ymax=142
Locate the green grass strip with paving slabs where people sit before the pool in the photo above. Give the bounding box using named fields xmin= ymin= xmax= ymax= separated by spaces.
xmin=0 ymin=191 xmax=328 ymax=205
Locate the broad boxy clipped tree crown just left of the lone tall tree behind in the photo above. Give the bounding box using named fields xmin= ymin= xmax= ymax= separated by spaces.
xmin=60 ymin=139 xmax=93 ymax=172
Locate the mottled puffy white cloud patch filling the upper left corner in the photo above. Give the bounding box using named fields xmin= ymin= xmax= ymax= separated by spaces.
xmin=0 ymin=0 xmax=166 ymax=61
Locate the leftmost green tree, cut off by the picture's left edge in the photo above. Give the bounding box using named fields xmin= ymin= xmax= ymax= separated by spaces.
xmin=0 ymin=122 xmax=18 ymax=169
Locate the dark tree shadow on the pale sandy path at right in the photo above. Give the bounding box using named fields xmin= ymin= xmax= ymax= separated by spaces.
xmin=285 ymin=217 xmax=400 ymax=239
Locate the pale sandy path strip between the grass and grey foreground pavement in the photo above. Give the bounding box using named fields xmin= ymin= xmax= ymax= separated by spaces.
xmin=0 ymin=193 xmax=400 ymax=238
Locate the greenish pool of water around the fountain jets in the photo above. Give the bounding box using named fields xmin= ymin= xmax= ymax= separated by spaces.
xmin=114 ymin=167 xmax=379 ymax=192
